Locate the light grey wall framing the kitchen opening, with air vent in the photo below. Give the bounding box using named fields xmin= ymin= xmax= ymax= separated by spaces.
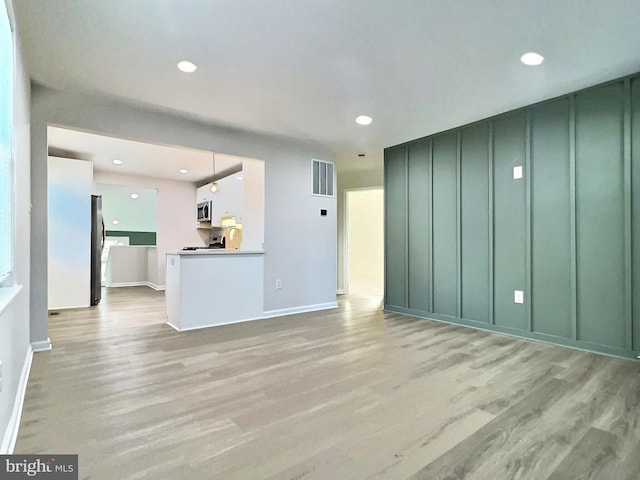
xmin=31 ymin=85 xmax=337 ymax=339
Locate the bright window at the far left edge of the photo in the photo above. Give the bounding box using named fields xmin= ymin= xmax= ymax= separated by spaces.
xmin=0 ymin=1 xmax=13 ymax=285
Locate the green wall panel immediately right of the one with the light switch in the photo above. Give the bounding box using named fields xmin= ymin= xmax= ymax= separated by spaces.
xmin=530 ymin=98 xmax=573 ymax=338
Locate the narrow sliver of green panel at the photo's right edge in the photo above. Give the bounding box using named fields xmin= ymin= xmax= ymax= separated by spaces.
xmin=631 ymin=77 xmax=640 ymax=350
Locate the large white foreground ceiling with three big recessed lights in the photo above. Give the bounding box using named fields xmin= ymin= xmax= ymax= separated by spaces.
xmin=15 ymin=0 xmax=640 ymax=173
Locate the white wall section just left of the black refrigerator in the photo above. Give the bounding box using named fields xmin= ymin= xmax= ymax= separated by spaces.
xmin=47 ymin=157 xmax=93 ymax=310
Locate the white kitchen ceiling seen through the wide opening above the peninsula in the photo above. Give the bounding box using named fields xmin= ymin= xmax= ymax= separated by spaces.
xmin=47 ymin=127 xmax=242 ymax=185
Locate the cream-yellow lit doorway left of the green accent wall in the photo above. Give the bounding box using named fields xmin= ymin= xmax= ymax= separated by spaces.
xmin=345 ymin=187 xmax=384 ymax=297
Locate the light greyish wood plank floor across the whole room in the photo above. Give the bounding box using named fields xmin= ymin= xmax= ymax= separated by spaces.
xmin=16 ymin=287 xmax=640 ymax=480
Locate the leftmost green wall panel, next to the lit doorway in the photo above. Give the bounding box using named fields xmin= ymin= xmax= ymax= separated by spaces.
xmin=384 ymin=147 xmax=407 ymax=307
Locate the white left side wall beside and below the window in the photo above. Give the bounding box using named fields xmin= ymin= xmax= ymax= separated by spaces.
xmin=0 ymin=2 xmax=31 ymax=454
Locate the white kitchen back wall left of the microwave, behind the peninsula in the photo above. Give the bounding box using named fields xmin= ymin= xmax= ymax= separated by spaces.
xmin=93 ymin=172 xmax=205 ymax=287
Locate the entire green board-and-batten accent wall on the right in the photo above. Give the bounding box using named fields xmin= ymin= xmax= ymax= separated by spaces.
xmin=385 ymin=75 xmax=640 ymax=359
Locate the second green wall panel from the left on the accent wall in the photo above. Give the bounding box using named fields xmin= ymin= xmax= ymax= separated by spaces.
xmin=407 ymin=140 xmax=431 ymax=312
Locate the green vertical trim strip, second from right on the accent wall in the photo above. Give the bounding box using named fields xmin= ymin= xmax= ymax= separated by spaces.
xmin=569 ymin=95 xmax=579 ymax=340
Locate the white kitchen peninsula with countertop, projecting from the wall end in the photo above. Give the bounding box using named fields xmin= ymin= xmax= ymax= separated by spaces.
xmin=166 ymin=249 xmax=264 ymax=331
